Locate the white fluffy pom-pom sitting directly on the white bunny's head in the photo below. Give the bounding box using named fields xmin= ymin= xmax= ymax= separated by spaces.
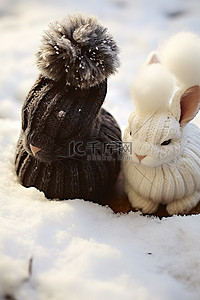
xmin=131 ymin=64 xmax=174 ymax=113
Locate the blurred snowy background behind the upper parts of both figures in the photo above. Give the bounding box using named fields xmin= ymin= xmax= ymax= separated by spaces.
xmin=0 ymin=0 xmax=200 ymax=129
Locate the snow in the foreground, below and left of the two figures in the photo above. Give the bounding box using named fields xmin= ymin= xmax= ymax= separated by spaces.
xmin=0 ymin=120 xmax=200 ymax=300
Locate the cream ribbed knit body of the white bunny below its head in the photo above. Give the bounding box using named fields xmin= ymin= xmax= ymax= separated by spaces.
xmin=123 ymin=124 xmax=200 ymax=214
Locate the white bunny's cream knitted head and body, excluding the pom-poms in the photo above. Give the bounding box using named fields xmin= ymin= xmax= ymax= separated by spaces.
xmin=123 ymin=90 xmax=200 ymax=215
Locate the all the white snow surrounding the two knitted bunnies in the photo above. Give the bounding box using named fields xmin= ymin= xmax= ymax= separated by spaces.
xmin=0 ymin=0 xmax=200 ymax=300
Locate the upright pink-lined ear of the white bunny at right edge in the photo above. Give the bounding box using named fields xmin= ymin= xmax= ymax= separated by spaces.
xmin=179 ymin=85 xmax=200 ymax=126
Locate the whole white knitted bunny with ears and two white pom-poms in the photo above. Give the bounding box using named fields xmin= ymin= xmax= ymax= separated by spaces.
xmin=123 ymin=32 xmax=200 ymax=215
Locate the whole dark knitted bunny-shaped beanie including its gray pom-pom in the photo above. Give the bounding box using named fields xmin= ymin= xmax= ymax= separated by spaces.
xmin=15 ymin=15 xmax=121 ymax=203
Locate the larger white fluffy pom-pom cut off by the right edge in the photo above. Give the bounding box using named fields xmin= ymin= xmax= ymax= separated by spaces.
xmin=159 ymin=31 xmax=200 ymax=87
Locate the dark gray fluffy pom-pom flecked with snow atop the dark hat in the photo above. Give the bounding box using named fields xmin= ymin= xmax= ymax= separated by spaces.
xmin=36 ymin=15 xmax=119 ymax=89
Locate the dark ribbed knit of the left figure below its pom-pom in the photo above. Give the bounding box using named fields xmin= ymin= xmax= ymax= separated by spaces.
xmin=15 ymin=77 xmax=121 ymax=201
